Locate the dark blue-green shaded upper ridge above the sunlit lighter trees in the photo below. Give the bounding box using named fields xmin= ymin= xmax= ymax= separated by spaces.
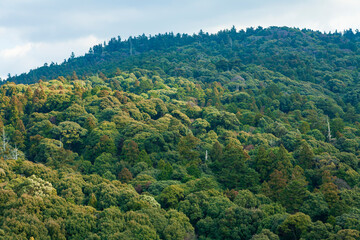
xmin=4 ymin=27 xmax=360 ymax=88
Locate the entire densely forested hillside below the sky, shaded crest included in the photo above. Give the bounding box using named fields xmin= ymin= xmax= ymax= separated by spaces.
xmin=0 ymin=27 xmax=360 ymax=240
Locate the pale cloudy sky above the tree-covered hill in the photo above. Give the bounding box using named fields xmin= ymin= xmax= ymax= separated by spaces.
xmin=0 ymin=0 xmax=360 ymax=79
